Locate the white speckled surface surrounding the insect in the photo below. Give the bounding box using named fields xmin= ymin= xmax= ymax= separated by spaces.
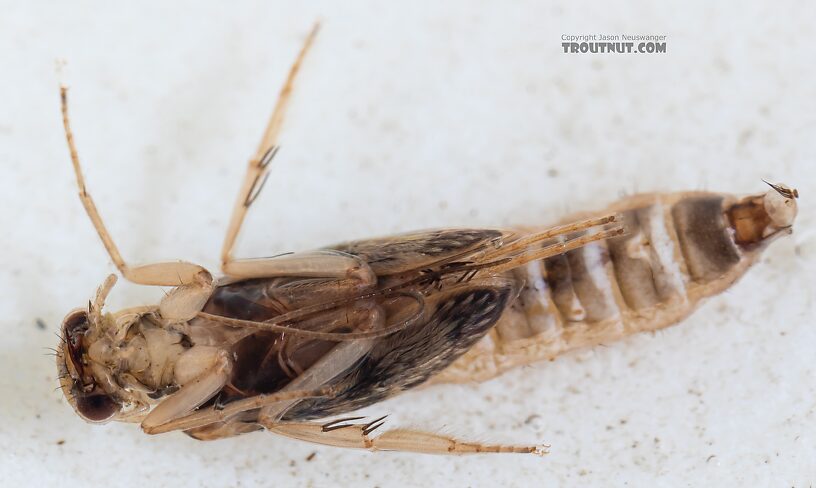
xmin=0 ymin=1 xmax=816 ymax=487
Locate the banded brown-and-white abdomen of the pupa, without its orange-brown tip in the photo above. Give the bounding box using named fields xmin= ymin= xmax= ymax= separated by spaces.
xmin=434 ymin=192 xmax=758 ymax=382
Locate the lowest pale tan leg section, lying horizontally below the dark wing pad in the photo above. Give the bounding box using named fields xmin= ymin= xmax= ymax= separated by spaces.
xmin=264 ymin=417 xmax=549 ymax=456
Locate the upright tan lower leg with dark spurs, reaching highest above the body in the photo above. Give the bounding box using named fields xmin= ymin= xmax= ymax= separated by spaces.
xmin=221 ymin=23 xmax=320 ymax=274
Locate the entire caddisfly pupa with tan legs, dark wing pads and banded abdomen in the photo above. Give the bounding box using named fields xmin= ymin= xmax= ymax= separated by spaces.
xmin=57 ymin=24 xmax=796 ymax=454
